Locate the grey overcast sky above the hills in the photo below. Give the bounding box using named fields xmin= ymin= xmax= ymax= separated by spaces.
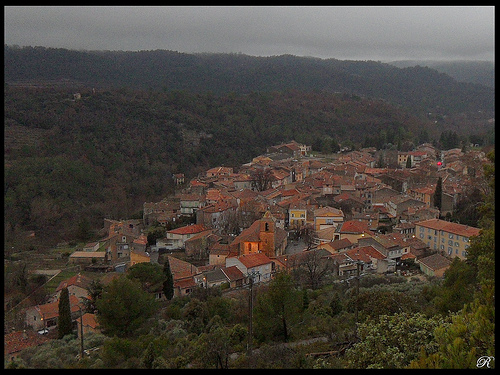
xmin=4 ymin=6 xmax=494 ymax=61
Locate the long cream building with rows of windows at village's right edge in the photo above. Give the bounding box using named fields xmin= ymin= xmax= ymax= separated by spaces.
xmin=415 ymin=219 xmax=480 ymax=259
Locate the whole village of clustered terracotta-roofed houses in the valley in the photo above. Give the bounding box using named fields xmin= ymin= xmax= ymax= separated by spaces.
xmin=6 ymin=141 xmax=487 ymax=353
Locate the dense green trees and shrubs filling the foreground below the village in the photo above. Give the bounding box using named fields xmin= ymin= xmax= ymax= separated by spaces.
xmin=6 ymin=152 xmax=495 ymax=369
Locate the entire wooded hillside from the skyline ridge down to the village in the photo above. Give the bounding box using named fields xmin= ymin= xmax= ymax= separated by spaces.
xmin=4 ymin=47 xmax=494 ymax=248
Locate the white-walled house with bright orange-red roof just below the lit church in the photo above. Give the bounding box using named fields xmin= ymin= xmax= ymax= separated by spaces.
xmin=226 ymin=253 xmax=274 ymax=283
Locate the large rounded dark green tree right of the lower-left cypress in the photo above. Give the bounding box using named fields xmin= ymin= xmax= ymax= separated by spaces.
xmin=96 ymin=276 xmax=158 ymax=337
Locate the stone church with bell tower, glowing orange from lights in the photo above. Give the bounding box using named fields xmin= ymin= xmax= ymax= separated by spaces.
xmin=229 ymin=211 xmax=287 ymax=257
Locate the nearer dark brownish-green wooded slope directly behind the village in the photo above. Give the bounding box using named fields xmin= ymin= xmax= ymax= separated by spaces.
xmin=4 ymin=87 xmax=462 ymax=248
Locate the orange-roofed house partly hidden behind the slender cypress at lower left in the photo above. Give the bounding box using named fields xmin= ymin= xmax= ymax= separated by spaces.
xmin=24 ymin=295 xmax=82 ymax=331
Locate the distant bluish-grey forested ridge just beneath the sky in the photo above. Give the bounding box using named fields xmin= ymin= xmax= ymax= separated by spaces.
xmin=4 ymin=45 xmax=494 ymax=117
